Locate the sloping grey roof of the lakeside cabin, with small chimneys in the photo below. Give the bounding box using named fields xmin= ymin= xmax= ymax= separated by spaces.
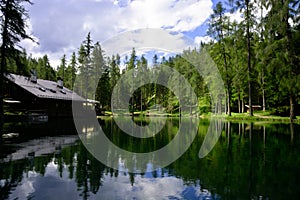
xmin=5 ymin=74 xmax=85 ymax=101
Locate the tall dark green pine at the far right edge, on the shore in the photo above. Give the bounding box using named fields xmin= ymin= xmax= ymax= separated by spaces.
xmin=266 ymin=0 xmax=300 ymax=120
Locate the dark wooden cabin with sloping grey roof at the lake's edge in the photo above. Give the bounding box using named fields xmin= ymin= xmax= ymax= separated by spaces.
xmin=4 ymin=73 xmax=86 ymax=117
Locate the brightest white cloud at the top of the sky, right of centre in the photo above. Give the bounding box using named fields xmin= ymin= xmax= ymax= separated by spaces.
xmin=117 ymin=0 xmax=212 ymax=31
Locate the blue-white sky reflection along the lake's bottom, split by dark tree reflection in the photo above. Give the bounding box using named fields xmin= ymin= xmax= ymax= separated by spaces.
xmin=9 ymin=161 xmax=216 ymax=199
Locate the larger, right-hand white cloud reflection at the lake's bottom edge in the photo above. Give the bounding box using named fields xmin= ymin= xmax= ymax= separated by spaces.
xmin=90 ymin=173 xmax=216 ymax=199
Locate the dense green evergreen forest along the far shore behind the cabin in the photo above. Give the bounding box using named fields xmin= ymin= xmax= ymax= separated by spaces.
xmin=1 ymin=0 xmax=300 ymax=119
